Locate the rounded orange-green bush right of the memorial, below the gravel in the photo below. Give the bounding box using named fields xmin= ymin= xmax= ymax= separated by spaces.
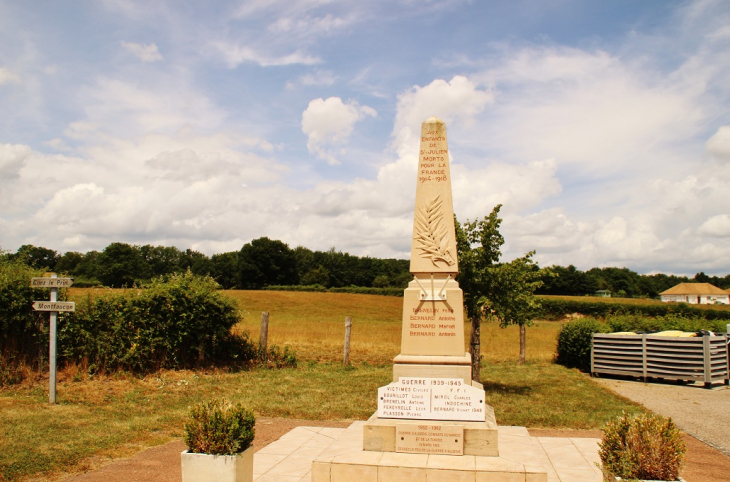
xmin=598 ymin=413 xmax=686 ymax=482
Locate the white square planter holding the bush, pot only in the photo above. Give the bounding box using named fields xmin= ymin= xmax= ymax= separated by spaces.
xmin=180 ymin=447 xmax=253 ymax=482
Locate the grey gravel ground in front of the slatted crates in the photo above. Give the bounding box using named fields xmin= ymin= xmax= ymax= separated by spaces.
xmin=594 ymin=378 xmax=730 ymax=455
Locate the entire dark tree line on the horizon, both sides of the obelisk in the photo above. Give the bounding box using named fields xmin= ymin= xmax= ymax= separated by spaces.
xmin=3 ymin=237 xmax=730 ymax=298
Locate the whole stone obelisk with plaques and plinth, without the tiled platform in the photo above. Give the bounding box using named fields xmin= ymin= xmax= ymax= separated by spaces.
xmin=363 ymin=117 xmax=498 ymax=457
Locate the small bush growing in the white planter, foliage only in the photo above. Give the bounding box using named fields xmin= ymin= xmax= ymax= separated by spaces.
xmin=185 ymin=399 xmax=256 ymax=455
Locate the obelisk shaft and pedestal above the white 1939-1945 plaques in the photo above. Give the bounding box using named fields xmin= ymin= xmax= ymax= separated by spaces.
xmin=393 ymin=117 xmax=471 ymax=384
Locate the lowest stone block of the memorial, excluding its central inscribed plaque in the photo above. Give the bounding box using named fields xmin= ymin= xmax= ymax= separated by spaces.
xmin=362 ymin=405 xmax=499 ymax=457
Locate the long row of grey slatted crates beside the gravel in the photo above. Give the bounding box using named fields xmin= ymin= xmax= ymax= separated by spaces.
xmin=591 ymin=333 xmax=730 ymax=385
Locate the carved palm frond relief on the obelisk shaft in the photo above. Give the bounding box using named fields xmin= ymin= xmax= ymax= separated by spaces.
xmin=415 ymin=194 xmax=456 ymax=266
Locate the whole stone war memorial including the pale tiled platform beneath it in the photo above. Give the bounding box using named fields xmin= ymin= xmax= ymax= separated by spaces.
xmin=312 ymin=117 xmax=547 ymax=482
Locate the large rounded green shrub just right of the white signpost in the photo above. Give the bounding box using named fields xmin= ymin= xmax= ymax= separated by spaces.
xmin=58 ymin=272 xmax=256 ymax=372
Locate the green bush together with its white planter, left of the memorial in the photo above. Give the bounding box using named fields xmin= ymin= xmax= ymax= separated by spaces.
xmin=181 ymin=399 xmax=256 ymax=482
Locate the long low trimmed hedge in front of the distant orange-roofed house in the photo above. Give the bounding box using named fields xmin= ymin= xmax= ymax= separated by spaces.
xmin=540 ymin=296 xmax=730 ymax=321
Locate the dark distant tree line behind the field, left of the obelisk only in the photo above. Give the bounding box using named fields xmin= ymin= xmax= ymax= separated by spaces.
xmin=2 ymin=237 xmax=411 ymax=289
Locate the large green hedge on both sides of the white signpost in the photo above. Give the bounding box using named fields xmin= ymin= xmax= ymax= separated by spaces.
xmin=0 ymin=268 xmax=258 ymax=385
